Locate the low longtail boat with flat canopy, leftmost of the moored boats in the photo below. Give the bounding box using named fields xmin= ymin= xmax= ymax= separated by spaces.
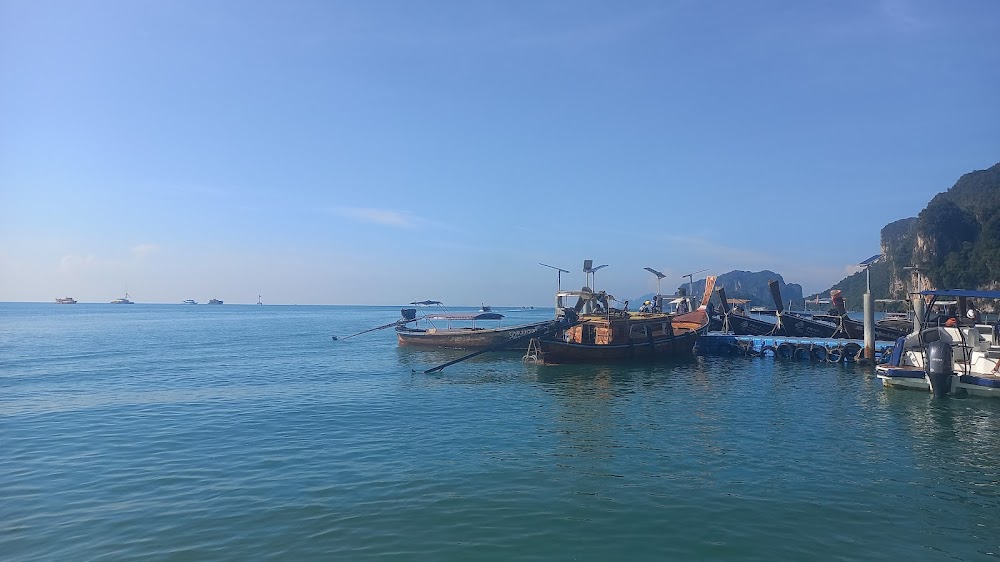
xmin=396 ymin=301 xmax=555 ymax=350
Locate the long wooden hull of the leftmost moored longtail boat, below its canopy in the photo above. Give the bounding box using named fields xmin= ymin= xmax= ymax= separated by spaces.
xmin=396 ymin=321 xmax=552 ymax=350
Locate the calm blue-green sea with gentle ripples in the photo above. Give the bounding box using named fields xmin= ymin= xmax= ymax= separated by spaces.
xmin=0 ymin=303 xmax=1000 ymax=561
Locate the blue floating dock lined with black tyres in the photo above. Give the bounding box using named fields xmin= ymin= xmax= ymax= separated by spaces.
xmin=695 ymin=332 xmax=895 ymax=363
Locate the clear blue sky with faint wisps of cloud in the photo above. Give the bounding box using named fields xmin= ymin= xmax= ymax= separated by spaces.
xmin=0 ymin=0 xmax=1000 ymax=306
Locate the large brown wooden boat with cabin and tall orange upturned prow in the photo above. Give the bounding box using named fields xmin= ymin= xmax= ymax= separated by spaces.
xmin=526 ymin=276 xmax=715 ymax=364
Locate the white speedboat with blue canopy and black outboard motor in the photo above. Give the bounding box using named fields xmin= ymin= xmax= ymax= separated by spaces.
xmin=876 ymin=289 xmax=1000 ymax=398
